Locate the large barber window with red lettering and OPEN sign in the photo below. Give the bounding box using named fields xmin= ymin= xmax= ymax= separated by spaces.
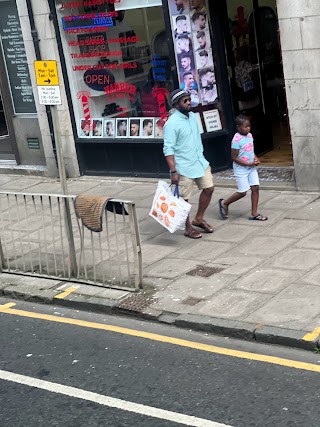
xmin=56 ymin=0 xmax=174 ymax=142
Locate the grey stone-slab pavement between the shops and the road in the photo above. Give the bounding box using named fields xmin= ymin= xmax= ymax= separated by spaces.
xmin=0 ymin=174 xmax=320 ymax=351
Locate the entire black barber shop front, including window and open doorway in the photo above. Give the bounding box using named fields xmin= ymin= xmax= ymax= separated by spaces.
xmin=49 ymin=0 xmax=292 ymax=177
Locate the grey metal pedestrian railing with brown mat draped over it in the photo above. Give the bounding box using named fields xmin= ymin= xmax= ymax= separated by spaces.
xmin=0 ymin=191 xmax=142 ymax=290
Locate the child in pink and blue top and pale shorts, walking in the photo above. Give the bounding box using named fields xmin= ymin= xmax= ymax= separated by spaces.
xmin=219 ymin=114 xmax=268 ymax=221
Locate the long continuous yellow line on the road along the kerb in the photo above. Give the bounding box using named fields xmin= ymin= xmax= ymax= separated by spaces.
xmin=0 ymin=306 xmax=320 ymax=372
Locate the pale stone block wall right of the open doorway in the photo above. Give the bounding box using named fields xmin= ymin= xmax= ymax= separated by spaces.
xmin=277 ymin=0 xmax=320 ymax=191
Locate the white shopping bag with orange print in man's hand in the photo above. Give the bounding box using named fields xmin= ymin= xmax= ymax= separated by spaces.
xmin=149 ymin=181 xmax=191 ymax=233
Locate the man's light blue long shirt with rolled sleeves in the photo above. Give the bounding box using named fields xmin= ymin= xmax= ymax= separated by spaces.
xmin=163 ymin=110 xmax=209 ymax=178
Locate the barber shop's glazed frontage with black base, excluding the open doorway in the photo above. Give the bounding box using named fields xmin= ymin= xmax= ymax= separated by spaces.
xmin=50 ymin=0 xmax=234 ymax=176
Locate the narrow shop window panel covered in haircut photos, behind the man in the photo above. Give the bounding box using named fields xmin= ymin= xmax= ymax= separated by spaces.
xmin=168 ymin=0 xmax=223 ymax=132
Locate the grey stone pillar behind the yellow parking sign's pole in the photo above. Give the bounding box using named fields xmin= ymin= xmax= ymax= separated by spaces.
xmin=17 ymin=0 xmax=79 ymax=177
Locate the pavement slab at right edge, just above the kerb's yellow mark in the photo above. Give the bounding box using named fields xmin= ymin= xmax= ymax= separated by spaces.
xmin=245 ymin=283 xmax=320 ymax=329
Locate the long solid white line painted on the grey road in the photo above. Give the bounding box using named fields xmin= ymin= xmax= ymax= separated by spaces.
xmin=0 ymin=370 xmax=231 ymax=427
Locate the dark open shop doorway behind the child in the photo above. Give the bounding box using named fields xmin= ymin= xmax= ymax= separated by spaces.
xmin=226 ymin=0 xmax=293 ymax=167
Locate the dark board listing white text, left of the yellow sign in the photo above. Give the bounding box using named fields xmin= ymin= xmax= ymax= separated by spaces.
xmin=0 ymin=0 xmax=36 ymax=114
